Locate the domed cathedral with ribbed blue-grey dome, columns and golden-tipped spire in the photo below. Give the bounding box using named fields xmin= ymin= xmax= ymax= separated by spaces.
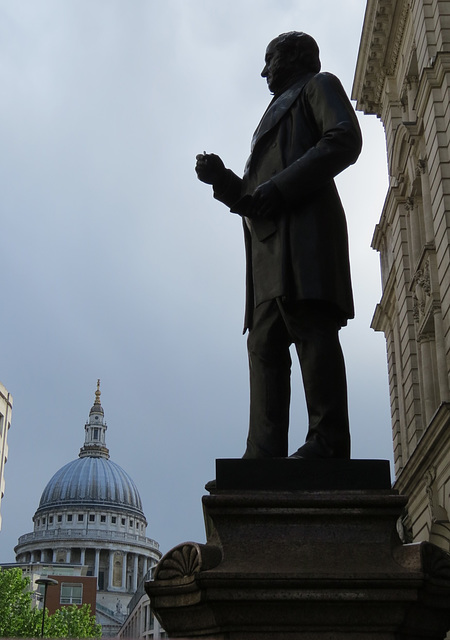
xmin=15 ymin=382 xmax=161 ymax=635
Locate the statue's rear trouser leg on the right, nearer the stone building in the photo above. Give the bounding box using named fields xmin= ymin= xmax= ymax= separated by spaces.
xmin=282 ymin=302 xmax=350 ymax=458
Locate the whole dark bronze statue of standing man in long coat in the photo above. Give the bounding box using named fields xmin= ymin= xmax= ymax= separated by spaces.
xmin=196 ymin=31 xmax=362 ymax=458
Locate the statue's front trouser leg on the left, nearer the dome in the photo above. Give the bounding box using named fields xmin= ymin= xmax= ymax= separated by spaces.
xmin=243 ymin=300 xmax=291 ymax=458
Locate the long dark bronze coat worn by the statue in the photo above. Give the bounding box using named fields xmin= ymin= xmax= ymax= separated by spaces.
xmin=214 ymin=73 xmax=362 ymax=331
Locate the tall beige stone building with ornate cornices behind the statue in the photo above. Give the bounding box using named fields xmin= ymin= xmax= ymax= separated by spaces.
xmin=352 ymin=0 xmax=450 ymax=551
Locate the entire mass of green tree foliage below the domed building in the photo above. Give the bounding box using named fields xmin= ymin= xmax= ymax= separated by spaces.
xmin=0 ymin=567 xmax=102 ymax=638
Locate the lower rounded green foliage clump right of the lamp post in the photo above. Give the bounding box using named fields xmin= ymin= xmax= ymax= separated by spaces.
xmin=44 ymin=604 xmax=102 ymax=638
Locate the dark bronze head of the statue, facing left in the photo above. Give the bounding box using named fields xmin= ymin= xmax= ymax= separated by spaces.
xmin=261 ymin=31 xmax=320 ymax=94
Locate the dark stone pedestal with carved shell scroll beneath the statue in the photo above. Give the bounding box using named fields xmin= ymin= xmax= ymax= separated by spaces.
xmin=146 ymin=459 xmax=450 ymax=640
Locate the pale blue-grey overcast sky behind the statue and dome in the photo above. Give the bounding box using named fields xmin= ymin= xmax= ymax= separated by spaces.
xmin=0 ymin=0 xmax=392 ymax=562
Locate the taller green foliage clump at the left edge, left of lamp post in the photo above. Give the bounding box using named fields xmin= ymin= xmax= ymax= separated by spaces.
xmin=0 ymin=568 xmax=42 ymax=638
